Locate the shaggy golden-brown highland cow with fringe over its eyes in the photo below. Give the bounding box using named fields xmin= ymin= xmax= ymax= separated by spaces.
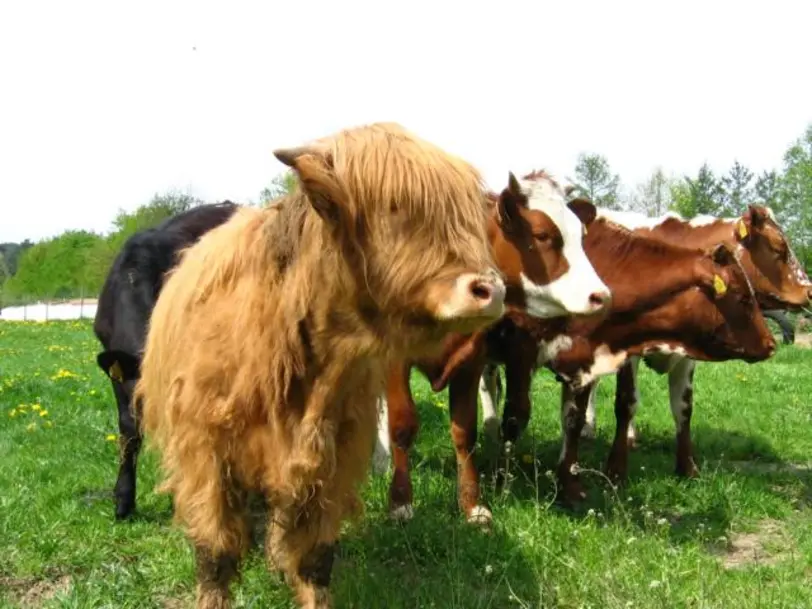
xmin=136 ymin=123 xmax=505 ymax=609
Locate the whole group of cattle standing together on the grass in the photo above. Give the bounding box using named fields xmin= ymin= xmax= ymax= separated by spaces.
xmin=84 ymin=123 xmax=812 ymax=609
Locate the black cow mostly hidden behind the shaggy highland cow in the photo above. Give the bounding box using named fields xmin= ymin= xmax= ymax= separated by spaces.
xmin=93 ymin=201 xmax=238 ymax=519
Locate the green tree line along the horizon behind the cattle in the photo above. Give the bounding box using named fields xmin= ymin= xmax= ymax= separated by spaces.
xmin=0 ymin=124 xmax=812 ymax=305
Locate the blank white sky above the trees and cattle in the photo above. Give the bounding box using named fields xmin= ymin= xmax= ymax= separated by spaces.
xmin=0 ymin=0 xmax=812 ymax=242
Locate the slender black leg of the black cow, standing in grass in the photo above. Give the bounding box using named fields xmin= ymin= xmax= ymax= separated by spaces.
xmin=111 ymin=381 xmax=141 ymax=520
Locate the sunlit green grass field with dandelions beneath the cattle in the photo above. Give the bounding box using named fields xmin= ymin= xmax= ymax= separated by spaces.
xmin=0 ymin=321 xmax=812 ymax=609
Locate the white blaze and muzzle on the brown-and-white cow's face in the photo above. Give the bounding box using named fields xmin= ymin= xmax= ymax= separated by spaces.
xmin=521 ymin=180 xmax=609 ymax=318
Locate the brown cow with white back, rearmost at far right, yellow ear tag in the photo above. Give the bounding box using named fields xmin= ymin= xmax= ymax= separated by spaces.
xmin=582 ymin=205 xmax=812 ymax=479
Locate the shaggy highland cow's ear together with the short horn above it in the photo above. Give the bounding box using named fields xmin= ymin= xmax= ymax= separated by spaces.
xmin=274 ymin=146 xmax=346 ymax=226
